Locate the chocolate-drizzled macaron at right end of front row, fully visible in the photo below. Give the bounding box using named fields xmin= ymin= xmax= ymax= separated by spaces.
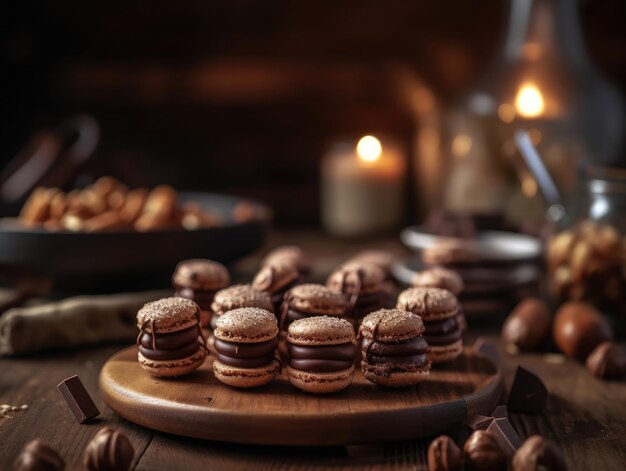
xmin=359 ymin=309 xmax=431 ymax=387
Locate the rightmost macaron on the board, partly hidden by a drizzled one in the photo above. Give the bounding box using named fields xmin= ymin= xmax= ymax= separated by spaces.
xmin=396 ymin=288 xmax=463 ymax=363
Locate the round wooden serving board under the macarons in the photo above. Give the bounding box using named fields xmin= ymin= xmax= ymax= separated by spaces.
xmin=100 ymin=346 xmax=502 ymax=445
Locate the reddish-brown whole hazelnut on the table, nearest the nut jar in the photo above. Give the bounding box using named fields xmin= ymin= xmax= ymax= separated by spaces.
xmin=553 ymin=301 xmax=613 ymax=361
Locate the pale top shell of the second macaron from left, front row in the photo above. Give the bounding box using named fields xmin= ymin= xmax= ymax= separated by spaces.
xmin=213 ymin=307 xmax=278 ymax=343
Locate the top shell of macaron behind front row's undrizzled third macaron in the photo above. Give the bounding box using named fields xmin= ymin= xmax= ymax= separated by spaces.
xmin=286 ymin=283 xmax=348 ymax=316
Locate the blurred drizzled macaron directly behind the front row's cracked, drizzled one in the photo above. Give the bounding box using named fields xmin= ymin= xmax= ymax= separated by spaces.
xmin=326 ymin=262 xmax=390 ymax=324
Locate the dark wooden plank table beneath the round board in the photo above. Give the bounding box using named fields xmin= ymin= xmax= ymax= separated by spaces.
xmin=0 ymin=230 xmax=626 ymax=471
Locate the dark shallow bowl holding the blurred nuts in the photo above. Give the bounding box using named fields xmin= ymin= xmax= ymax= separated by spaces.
xmin=0 ymin=193 xmax=271 ymax=292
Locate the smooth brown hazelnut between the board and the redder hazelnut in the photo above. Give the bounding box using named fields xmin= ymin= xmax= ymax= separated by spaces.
xmin=502 ymin=298 xmax=552 ymax=350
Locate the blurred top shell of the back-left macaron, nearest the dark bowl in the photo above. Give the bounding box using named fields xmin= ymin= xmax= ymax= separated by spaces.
xmin=172 ymin=258 xmax=230 ymax=291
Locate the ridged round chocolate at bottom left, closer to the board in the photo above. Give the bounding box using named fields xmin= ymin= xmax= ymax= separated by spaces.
xmin=83 ymin=427 xmax=135 ymax=471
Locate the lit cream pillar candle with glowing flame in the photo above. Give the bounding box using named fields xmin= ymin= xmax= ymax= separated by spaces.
xmin=322 ymin=136 xmax=406 ymax=236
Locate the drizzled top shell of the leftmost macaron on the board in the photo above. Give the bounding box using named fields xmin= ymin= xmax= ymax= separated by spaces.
xmin=137 ymin=297 xmax=200 ymax=334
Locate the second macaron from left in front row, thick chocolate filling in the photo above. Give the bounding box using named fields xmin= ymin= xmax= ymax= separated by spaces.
xmin=213 ymin=307 xmax=280 ymax=388
